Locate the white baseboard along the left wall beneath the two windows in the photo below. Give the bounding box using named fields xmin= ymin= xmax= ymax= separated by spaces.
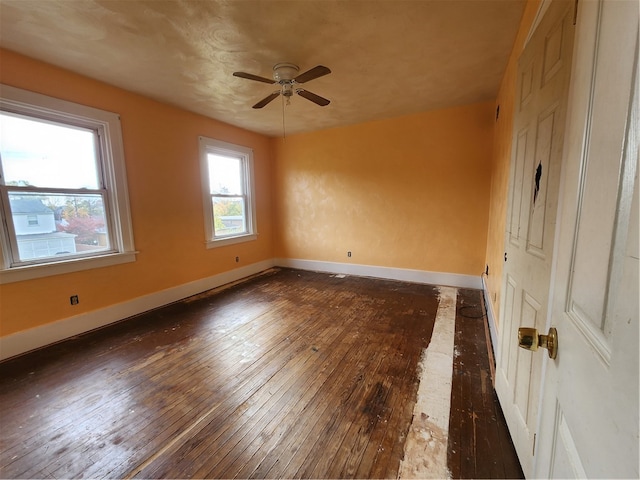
xmin=0 ymin=260 xmax=274 ymax=360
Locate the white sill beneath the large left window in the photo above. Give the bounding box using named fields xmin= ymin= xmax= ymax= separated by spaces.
xmin=0 ymin=252 xmax=137 ymax=285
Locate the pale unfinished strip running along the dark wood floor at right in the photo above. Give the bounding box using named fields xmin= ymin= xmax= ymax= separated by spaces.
xmin=398 ymin=287 xmax=457 ymax=478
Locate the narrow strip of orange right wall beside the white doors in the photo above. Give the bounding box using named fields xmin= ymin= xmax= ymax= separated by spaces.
xmin=485 ymin=0 xmax=540 ymax=322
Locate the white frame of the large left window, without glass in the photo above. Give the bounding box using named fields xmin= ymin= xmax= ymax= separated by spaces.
xmin=0 ymin=84 xmax=137 ymax=284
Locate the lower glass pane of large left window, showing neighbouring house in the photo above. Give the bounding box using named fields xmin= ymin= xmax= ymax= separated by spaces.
xmin=9 ymin=191 xmax=110 ymax=261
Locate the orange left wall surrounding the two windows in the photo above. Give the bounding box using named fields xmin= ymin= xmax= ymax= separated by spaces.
xmin=0 ymin=50 xmax=273 ymax=336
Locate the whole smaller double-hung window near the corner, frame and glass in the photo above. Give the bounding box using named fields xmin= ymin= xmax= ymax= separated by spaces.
xmin=200 ymin=137 xmax=257 ymax=247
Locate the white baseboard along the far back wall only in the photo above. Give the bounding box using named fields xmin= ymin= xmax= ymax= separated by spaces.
xmin=275 ymin=258 xmax=482 ymax=289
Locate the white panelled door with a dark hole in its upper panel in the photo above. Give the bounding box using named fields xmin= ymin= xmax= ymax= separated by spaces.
xmin=496 ymin=1 xmax=575 ymax=477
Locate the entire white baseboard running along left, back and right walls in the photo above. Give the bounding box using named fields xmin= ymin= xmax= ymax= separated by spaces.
xmin=0 ymin=258 xmax=480 ymax=360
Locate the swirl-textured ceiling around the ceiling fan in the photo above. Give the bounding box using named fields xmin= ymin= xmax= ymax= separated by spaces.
xmin=0 ymin=0 xmax=525 ymax=136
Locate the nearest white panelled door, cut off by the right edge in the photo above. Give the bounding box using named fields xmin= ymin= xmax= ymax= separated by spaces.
xmin=533 ymin=0 xmax=640 ymax=478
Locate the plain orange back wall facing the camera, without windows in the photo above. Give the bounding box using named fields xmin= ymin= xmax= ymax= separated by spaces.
xmin=272 ymin=102 xmax=494 ymax=275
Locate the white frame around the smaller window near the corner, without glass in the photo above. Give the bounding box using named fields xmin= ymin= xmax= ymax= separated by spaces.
xmin=199 ymin=136 xmax=258 ymax=248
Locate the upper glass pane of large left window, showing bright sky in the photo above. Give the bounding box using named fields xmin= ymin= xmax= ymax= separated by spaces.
xmin=0 ymin=112 xmax=100 ymax=189
